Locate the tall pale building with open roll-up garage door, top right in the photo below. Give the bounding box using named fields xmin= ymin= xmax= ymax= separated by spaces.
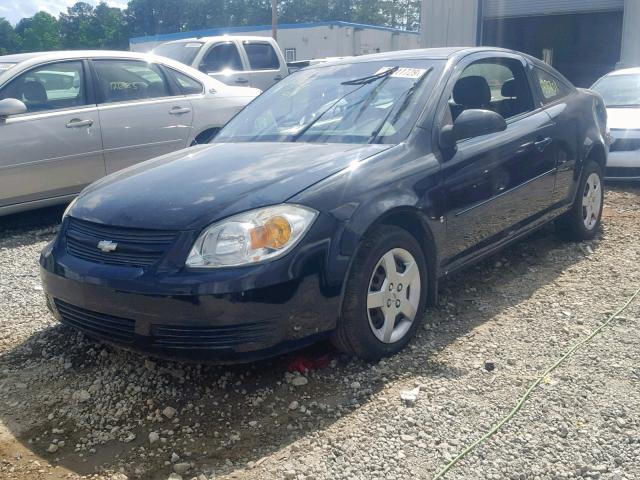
xmin=421 ymin=0 xmax=640 ymax=86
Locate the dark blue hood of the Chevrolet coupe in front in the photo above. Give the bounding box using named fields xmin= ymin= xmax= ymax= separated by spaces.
xmin=70 ymin=142 xmax=389 ymax=230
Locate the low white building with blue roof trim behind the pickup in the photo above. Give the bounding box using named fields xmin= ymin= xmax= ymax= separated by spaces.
xmin=129 ymin=21 xmax=420 ymax=62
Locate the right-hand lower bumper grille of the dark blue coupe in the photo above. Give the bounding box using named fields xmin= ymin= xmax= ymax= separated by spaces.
xmin=152 ymin=322 xmax=273 ymax=349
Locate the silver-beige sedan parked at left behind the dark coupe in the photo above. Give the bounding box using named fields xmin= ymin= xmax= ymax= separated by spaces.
xmin=0 ymin=51 xmax=261 ymax=215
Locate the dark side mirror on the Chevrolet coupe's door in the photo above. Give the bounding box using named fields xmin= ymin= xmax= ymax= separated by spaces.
xmin=440 ymin=109 xmax=507 ymax=149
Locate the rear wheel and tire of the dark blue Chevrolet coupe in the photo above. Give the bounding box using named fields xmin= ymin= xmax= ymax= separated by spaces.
xmin=556 ymin=160 xmax=604 ymax=241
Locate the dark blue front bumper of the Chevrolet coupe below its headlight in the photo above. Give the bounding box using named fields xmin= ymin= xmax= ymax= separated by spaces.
xmin=40 ymin=219 xmax=340 ymax=362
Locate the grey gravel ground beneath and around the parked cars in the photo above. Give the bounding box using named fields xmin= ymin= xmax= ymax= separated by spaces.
xmin=0 ymin=185 xmax=640 ymax=480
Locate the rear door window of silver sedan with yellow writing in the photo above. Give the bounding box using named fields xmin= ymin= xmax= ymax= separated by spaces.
xmin=93 ymin=60 xmax=171 ymax=103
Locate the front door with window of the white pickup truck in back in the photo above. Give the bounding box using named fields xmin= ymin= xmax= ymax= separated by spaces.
xmin=198 ymin=40 xmax=251 ymax=87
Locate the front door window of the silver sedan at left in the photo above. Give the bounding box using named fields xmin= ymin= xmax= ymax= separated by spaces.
xmin=0 ymin=61 xmax=87 ymax=113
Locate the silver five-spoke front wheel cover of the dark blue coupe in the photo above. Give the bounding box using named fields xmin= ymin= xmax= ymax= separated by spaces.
xmin=367 ymin=248 xmax=421 ymax=343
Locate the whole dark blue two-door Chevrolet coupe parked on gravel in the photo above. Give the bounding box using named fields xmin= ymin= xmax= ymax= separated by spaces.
xmin=40 ymin=48 xmax=608 ymax=361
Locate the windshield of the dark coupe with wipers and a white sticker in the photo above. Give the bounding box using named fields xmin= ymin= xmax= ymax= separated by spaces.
xmin=215 ymin=60 xmax=439 ymax=143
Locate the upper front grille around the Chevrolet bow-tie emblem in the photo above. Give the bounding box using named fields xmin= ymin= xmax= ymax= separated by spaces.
xmin=65 ymin=218 xmax=177 ymax=267
